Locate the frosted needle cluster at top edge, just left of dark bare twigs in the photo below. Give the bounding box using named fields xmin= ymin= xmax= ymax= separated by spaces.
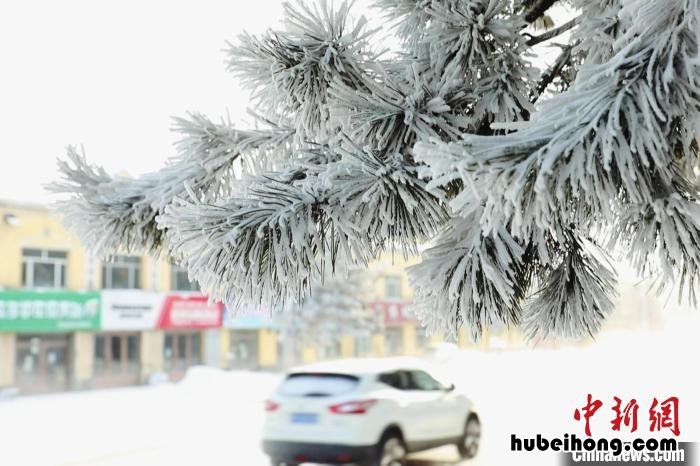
xmin=375 ymin=0 xmax=536 ymax=126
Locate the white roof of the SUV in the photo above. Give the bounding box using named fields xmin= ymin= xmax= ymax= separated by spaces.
xmin=287 ymin=357 xmax=426 ymax=375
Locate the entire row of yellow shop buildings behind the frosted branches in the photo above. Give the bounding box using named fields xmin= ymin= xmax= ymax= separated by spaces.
xmin=0 ymin=198 xmax=492 ymax=394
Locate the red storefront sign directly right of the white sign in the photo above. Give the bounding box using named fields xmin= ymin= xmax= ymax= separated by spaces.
xmin=157 ymin=295 xmax=224 ymax=329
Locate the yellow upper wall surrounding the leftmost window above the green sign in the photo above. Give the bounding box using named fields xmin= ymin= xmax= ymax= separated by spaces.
xmin=0 ymin=203 xmax=86 ymax=290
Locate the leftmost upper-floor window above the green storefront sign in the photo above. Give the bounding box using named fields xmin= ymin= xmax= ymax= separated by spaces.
xmin=22 ymin=249 xmax=68 ymax=288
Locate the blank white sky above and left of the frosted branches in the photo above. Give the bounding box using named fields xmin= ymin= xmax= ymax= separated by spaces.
xmin=0 ymin=0 xmax=558 ymax=202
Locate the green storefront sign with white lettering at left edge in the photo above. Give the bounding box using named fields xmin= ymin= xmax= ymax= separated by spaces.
xmin=0 ymin=290 xmax=100 ymax=332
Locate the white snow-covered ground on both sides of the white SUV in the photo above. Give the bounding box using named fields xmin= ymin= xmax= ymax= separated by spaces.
xmin=0 ymin=319 xmax=700 ymax=466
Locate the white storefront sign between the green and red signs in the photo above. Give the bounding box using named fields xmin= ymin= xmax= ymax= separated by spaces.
xmin=102 ymin=290 xmax=163 ymax=330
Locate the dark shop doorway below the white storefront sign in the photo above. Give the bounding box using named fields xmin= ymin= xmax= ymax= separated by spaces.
xmin=92 ymin=332 xmax=140 ymax=388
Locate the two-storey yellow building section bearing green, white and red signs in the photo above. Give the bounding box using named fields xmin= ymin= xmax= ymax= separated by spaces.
xmin=0 ymin=202 xmax=230 ymax=393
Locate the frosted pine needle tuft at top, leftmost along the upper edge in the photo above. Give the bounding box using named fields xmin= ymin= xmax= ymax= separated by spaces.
xmin=228 ymin=0 xmax=375 ymax=141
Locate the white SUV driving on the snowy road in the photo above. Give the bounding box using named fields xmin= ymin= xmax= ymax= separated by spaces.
xmin=263 ymin=358 xmax=481 ymax=466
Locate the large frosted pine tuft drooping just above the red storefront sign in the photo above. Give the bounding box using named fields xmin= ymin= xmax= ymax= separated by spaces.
xmin=160 ymin=171 xmax=360 ymax=309
